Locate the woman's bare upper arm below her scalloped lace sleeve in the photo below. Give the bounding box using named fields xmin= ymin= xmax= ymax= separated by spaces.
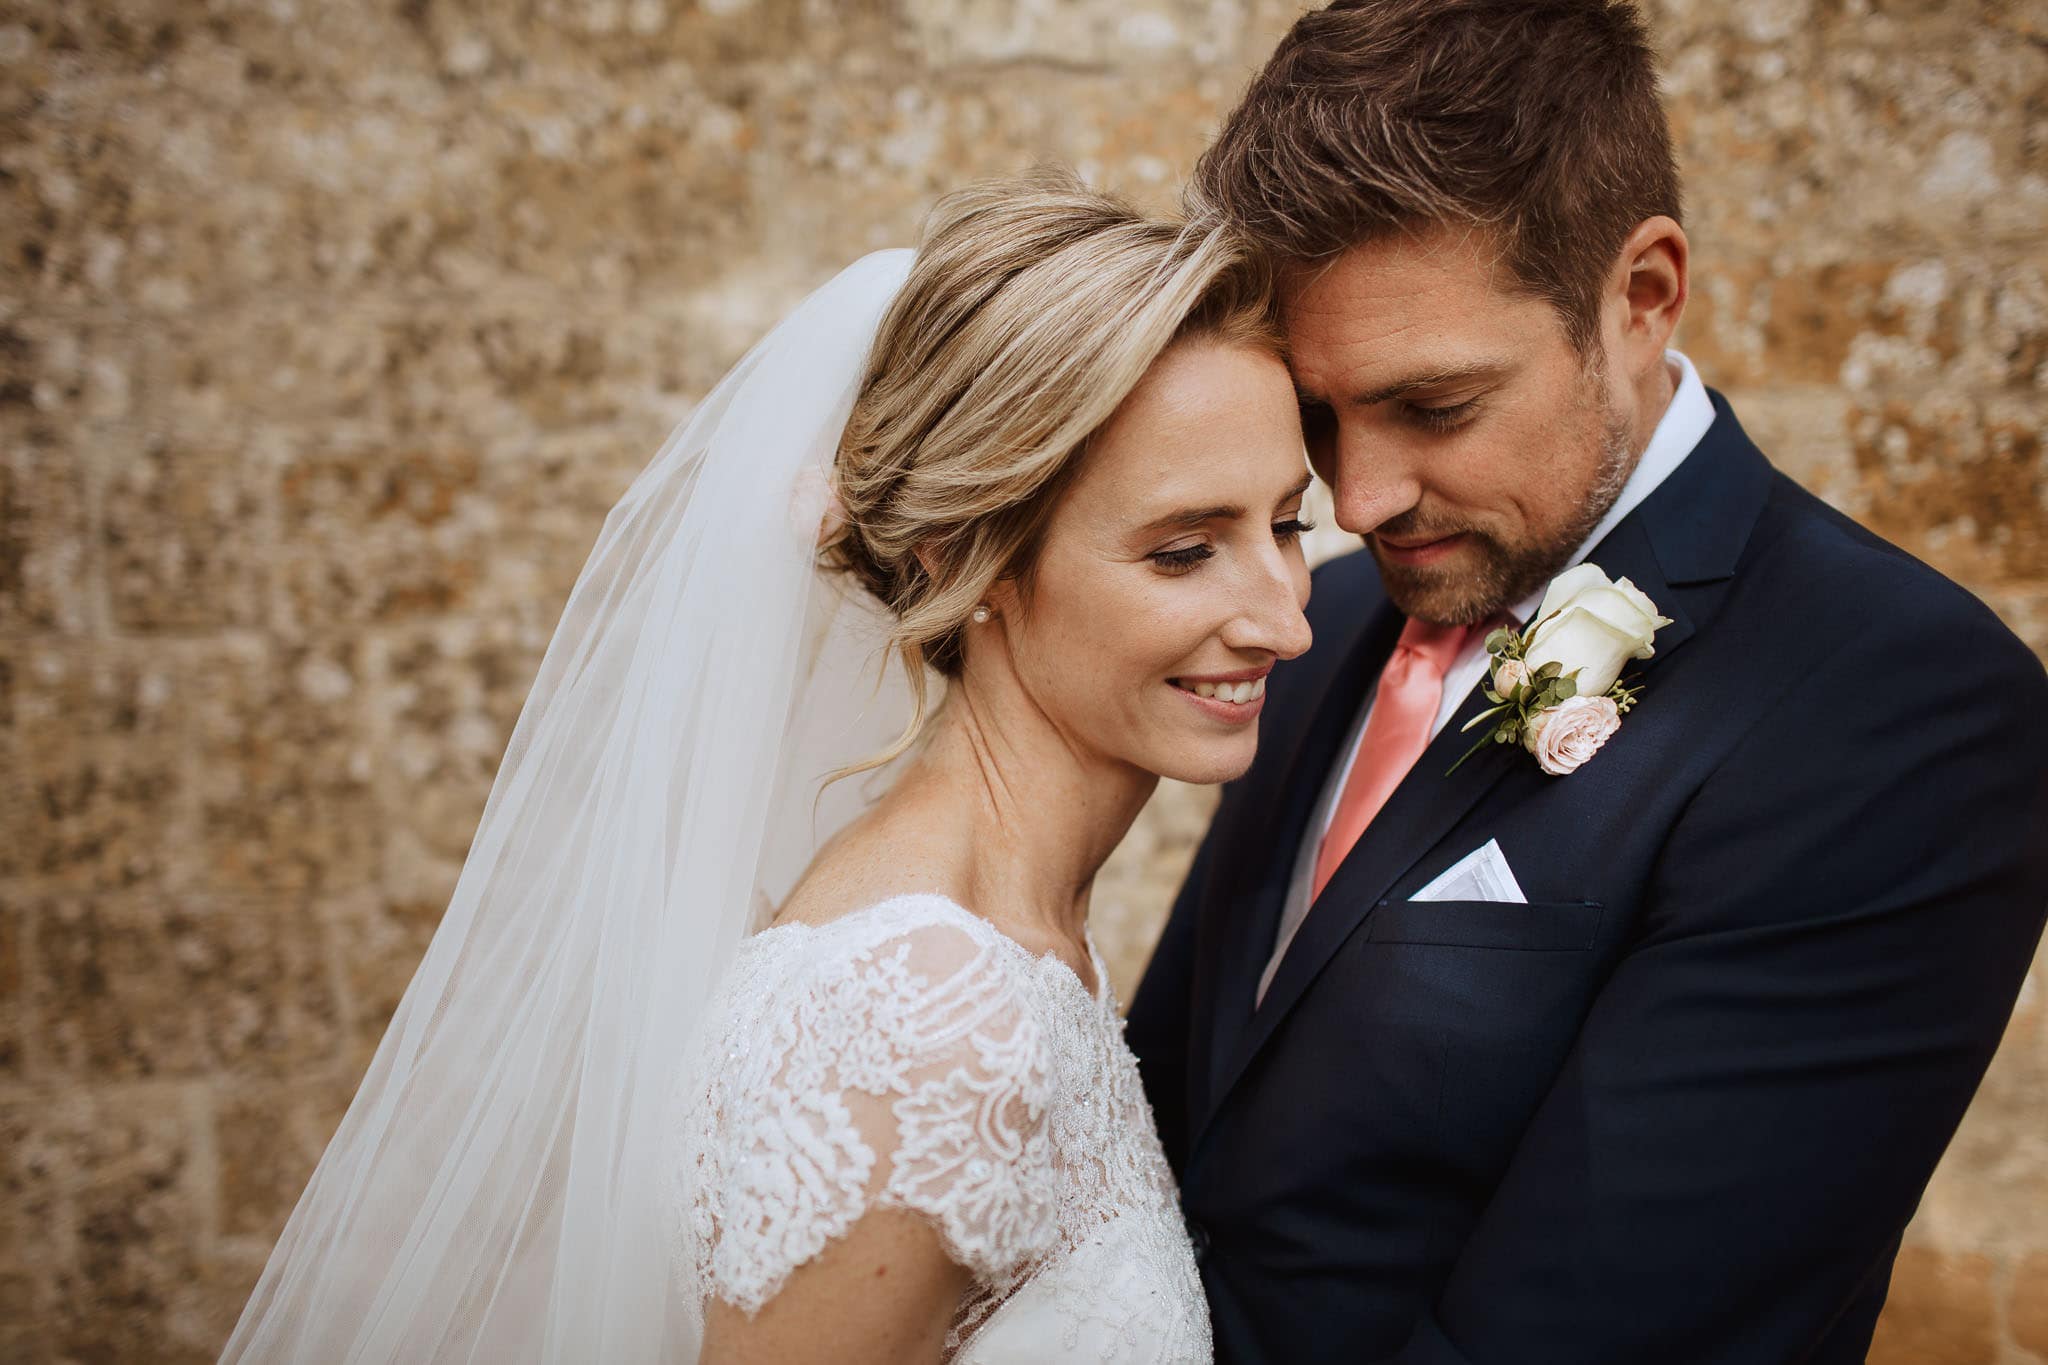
xmin=700 ymin=1209 xmax=969 ymax=1365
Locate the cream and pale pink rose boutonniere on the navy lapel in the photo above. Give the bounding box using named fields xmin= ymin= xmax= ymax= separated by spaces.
xmin=1444 ymin=565 xmax=1671 ymax=778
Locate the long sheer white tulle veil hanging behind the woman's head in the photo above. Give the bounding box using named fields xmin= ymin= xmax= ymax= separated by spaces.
xmin=223 ymin=252 xmax=911 ymax=1365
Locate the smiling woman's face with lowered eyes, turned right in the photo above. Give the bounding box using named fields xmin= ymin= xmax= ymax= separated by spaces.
xmin=991 ymin=340 xmax=1309 ymax=782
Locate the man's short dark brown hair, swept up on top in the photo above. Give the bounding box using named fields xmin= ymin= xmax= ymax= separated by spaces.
xmin=1194 ymin=0 xmax=1679 ymax=350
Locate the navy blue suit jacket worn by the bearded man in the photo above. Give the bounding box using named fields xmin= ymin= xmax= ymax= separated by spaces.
xmin=1128 ymin=395 xmax=2048 ymax=1365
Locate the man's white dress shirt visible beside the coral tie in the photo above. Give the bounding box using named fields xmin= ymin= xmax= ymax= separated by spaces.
xmin=1260 ymin=350 xmax=1714 ymax=1001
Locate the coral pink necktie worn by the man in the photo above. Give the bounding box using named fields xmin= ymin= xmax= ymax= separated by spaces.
xmin=1309 ymin=618 xmax=1483 ymax=900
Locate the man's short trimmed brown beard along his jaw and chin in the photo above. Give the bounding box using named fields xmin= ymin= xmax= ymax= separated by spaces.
xmin=1366 ymin=397 xmax=1638 ymax=626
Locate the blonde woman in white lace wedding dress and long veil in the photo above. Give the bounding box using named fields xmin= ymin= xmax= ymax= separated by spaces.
xmin=223 ymin=174 xmax=1309 ymax=1365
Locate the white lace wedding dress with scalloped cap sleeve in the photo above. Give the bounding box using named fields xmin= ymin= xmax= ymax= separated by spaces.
xmin=668 ymin=894 xmax=1210 ymax=1365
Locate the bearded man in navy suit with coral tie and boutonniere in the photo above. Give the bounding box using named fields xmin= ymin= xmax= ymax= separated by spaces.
xmin=1128 ymin=0 xmax=2048 ymax=1365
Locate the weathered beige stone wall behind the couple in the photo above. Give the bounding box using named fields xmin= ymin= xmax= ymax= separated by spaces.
xmin=0 ymin=0 xmax=2048 ymax=1365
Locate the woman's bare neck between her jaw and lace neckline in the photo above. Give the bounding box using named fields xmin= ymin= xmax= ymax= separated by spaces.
xmin=893 ymin=679 xmax=1159 ymax=943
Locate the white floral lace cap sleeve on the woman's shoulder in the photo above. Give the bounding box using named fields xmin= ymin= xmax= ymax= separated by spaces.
xmin=692 ymin=923 xmax=1057 ymax=1312
